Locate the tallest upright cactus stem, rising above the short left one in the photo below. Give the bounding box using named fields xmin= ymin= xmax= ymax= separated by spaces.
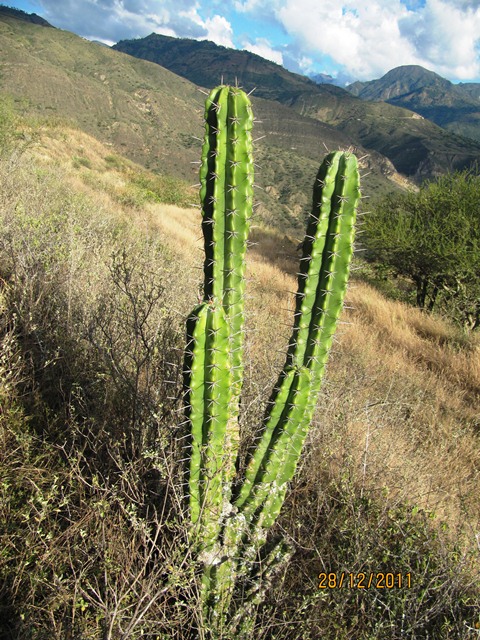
xmin=200 ymin=86 xmax=254 ymax=479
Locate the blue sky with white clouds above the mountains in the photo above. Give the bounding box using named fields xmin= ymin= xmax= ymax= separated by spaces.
xmin=3 ymin=0 xmax=480 ymax=83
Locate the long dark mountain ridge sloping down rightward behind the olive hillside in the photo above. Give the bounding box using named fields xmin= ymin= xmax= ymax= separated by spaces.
xmin=114 ymin=34 xmax=480 ymax=182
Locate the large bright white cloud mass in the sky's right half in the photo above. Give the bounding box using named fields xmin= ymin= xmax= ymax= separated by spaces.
xmin=240 ymin=0 xmax=480 ymax=79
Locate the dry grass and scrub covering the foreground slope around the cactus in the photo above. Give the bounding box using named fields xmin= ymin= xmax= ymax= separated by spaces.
xmin=0 ymin=112 xmax=480 ymax=640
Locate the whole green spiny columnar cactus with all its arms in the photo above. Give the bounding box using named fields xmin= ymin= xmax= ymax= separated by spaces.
xmin=184 ymin=85 xmax=360 ymax=637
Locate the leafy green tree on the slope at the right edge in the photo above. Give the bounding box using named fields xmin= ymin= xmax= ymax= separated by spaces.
xmin=366 ymin=171 xmax=480 ymax=329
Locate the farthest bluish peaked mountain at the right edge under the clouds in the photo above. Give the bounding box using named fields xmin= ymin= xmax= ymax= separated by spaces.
xmin=347 ymin=65 xmax=480 ymax=141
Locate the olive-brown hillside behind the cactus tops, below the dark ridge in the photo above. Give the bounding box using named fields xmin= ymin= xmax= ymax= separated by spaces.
xmin=0 ymin=15 xmax=402 ymax=230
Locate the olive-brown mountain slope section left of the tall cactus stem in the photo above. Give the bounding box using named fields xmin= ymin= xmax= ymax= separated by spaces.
xmin=0 ymin=15 xmax=201 ymax=177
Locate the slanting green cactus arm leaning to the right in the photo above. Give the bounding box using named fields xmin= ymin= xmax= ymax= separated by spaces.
xmin=231 ymin=152 xmax=360 ymax=527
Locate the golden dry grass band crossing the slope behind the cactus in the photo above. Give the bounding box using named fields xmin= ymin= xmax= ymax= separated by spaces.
xmin=37 ymin=121 xmax=480 ymax=544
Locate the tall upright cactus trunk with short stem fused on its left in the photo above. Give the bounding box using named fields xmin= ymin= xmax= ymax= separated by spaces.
xmin=185 ymin=86 xmax=253 ymax=618
